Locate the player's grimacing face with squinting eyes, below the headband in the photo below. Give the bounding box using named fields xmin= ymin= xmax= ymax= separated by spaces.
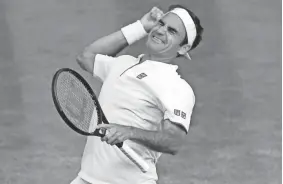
xmin=146 ymin=13 xmax=189 ymax=58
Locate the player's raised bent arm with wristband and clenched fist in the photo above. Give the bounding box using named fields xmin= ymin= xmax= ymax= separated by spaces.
xmin=77 ymin=7 xmax=163 ymax=73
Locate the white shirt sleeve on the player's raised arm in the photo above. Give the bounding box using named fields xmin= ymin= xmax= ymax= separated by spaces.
xmin=93 ymin=54 xmax=116 ymax=81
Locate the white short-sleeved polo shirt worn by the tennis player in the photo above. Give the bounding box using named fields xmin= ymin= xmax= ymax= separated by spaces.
xmin=79 ymin=54 xmax=195 ymax=184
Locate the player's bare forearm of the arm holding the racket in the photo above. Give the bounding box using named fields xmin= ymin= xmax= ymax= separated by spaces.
xmin=130 ymin=127 xmax=182 ymax=155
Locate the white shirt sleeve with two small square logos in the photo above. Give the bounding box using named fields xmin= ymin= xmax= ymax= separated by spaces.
xmin=161 ymin=81 xmax=195 ymax=133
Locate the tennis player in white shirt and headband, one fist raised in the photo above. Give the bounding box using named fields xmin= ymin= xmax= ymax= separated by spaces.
xmin=72 ymin=5 xmax=203 ymax=184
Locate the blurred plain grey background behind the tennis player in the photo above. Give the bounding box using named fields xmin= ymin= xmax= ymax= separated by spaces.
xmin=0 ymin=0 xmax=282 ymax=184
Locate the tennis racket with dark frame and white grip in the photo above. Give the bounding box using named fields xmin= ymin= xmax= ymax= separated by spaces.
xmin=52 ymin=68 xmax=149 ymax=172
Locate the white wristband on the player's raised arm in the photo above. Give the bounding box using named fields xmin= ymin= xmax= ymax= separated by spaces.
xmin=121 ymin=20 xmax=147 ymax=45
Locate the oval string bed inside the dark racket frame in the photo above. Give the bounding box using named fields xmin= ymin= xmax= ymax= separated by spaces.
xmin=57 ymin=72 xmax=98 ymax=133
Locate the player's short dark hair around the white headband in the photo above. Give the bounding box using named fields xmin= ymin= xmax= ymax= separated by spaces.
xmin=169 ymin=5 xmax=203 ymax=50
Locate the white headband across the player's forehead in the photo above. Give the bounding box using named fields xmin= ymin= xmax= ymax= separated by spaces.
xmin=170 ymin=8 xmax=197 ymax=46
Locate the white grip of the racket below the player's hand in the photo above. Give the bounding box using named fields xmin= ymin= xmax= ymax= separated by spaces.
xmin=119 ymin=143 xmax=149 ymax=173
